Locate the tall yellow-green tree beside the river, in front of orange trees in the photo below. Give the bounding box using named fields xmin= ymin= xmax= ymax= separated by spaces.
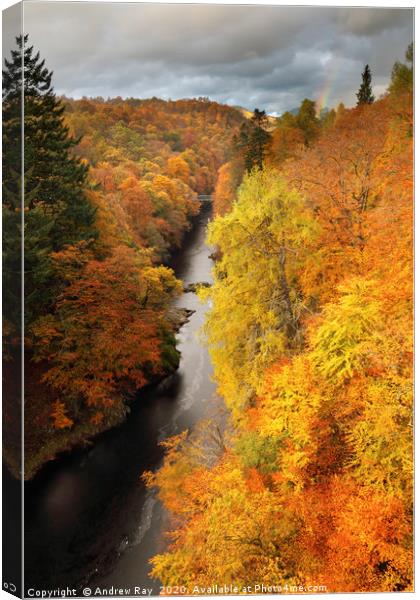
xmin=203 ymin=169 xmax=315 ymax=414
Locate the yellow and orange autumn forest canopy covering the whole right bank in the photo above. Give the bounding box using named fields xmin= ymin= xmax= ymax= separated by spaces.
xmin=145 ymin=47 xmax=413 ymax=592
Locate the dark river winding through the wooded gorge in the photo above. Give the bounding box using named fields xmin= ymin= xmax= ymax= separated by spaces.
xmin=25 ymin=204 xmax=221 ymax=595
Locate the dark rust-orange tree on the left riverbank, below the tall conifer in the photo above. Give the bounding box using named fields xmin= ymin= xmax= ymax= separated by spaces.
xmin=32 ymin=246 xmax=180 ymax=427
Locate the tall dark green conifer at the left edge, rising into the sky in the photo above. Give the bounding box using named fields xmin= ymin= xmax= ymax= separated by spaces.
xmin=3 ymin=36 xmax=97 ymax=321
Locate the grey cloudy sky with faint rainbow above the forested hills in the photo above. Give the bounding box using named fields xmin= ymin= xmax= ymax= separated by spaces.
xmin=11 ymin=2 xmax=413 ymax=114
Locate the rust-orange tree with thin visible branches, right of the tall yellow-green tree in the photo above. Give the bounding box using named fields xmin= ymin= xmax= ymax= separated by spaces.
xmin=286 ymin=102 xmax=389 ymax=300
